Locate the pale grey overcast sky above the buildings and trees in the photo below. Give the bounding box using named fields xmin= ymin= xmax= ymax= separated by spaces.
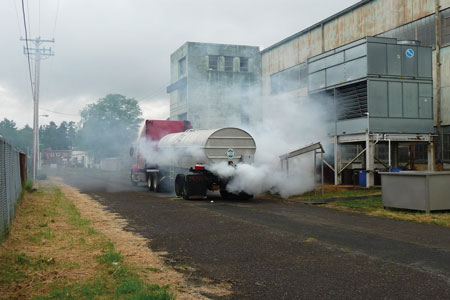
xmin=0 ymin=0 xmax=358 ymax=127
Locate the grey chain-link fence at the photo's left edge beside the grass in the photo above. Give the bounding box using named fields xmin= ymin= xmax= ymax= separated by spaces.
xmin=0 ymin=137 xmax=26 ymax=241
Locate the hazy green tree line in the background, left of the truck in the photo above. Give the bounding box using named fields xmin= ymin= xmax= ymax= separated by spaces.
xmin=0 ymin=94 xmax=143 ymax=161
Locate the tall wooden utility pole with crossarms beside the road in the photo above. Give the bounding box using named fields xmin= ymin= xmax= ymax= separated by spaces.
xmin=20 ymin=37 xmax=55 ymax=181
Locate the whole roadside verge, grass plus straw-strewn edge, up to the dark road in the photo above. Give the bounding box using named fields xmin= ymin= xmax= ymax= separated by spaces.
xmin=0 ymin=178 xmax=230 ymax=299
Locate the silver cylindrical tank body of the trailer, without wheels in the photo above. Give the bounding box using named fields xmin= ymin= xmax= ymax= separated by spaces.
xmin=158 ymin=127 xmax=256 ymax=168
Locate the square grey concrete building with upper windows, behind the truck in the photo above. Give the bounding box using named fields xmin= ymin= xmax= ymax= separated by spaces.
xmin=167 ymin=42 xmax=261 ymax=129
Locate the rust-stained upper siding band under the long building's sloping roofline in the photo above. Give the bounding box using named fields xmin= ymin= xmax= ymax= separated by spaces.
xmin=262 ymin=0 xmax=442 ymax=79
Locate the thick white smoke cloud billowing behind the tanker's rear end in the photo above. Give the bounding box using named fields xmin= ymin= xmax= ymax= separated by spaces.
xmin=207 ymin=93 xmax=327 ymax=197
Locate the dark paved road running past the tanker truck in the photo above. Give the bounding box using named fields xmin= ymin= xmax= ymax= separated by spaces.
xmin=55 ymin=172 xmax=450 ymax=299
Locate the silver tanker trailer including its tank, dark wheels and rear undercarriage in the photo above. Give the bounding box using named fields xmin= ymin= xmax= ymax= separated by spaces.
xmin=158 ymin=127 xmax=256 ymax=200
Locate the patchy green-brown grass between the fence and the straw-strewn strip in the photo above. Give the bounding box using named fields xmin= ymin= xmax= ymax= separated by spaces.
xmin=0 ymin=187 xmax=174 ymax=300
